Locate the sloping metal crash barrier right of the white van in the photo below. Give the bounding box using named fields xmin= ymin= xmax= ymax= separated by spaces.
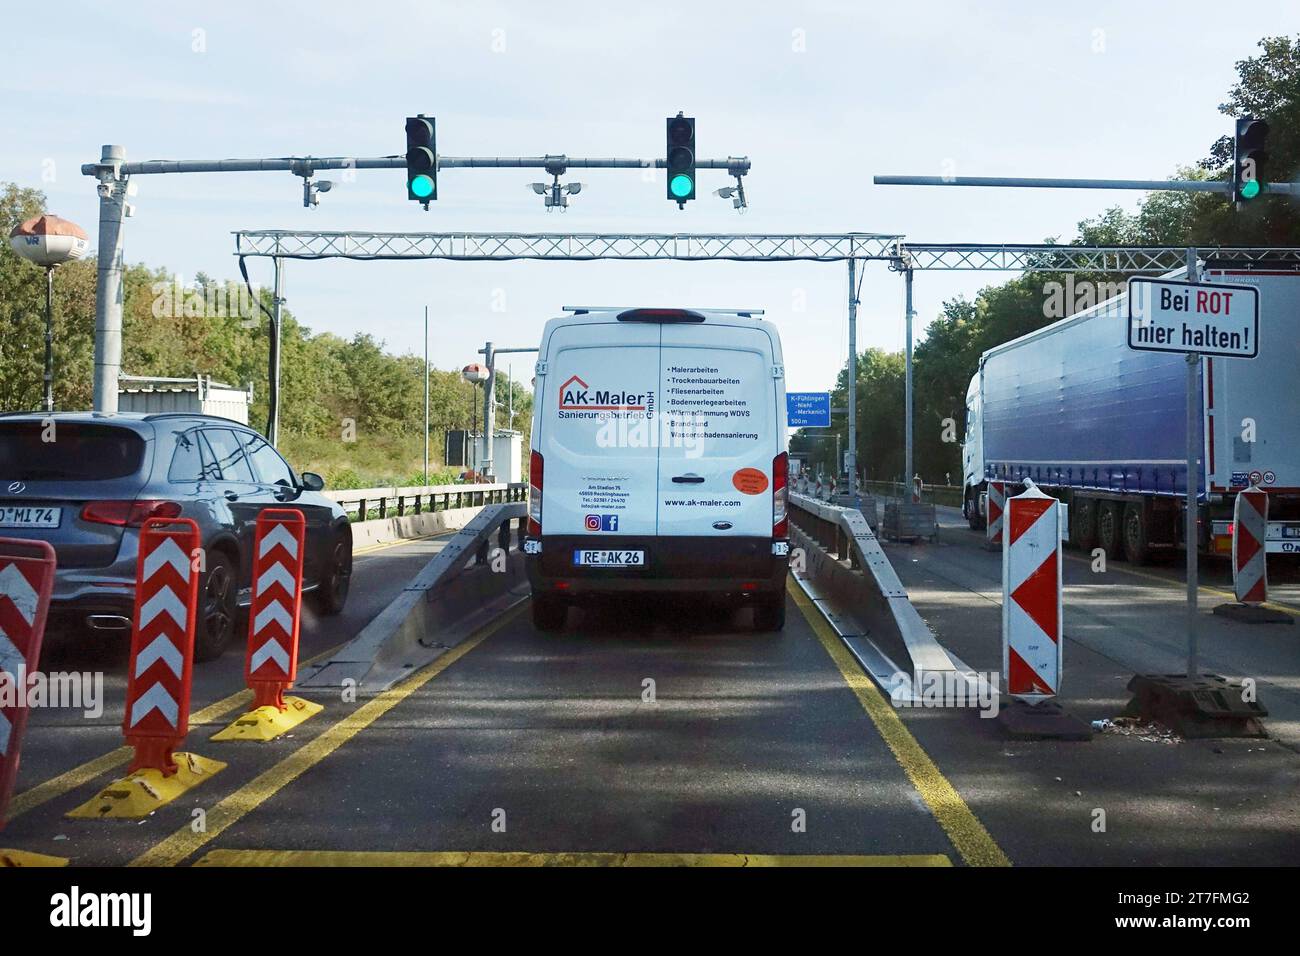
xmin=789 ymin=494 xmax=967 ymax=693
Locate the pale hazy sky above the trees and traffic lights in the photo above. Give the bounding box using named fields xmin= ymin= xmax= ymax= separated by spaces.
xmin=0 ymin=0 xmax=1300 ymax=390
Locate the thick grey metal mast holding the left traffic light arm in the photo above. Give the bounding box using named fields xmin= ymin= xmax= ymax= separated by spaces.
xmin=91 ymin=146 xmax=127 ymax=415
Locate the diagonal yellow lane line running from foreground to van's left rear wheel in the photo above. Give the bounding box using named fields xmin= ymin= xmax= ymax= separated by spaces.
xmin=129 ymin=604 xmax=527 ymax=866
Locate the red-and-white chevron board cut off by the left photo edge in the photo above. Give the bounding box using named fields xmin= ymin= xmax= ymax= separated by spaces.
xmin=0 ymin=537 xmax=55 ymax=827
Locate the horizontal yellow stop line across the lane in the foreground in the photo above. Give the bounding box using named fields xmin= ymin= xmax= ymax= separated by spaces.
xmin=195 ymin=849 xmax=953 ymax=866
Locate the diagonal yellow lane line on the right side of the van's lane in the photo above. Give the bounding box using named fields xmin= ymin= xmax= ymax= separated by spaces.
xmin=785 ymin=581 xmax=1011 ymax=866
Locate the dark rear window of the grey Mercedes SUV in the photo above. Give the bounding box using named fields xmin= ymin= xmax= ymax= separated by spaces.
xmin=0 ymin=420 xmax=144 ymax=481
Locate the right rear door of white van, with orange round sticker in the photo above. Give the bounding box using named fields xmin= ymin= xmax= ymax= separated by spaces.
xmin=658 ymin=321 xmax=785 ymax=537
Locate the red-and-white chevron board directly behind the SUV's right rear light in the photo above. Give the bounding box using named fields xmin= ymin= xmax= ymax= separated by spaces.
xmin=122 ymin=518 xmax=199 ymax=777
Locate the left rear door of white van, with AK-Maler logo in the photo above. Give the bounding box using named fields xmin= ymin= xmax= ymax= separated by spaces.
xmin=533 ymin=321 xmax=660 ymax=544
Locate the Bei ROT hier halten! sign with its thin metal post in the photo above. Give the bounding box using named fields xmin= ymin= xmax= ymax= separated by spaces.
xmin=1128 ymin=248 xmax=1260 ymax=679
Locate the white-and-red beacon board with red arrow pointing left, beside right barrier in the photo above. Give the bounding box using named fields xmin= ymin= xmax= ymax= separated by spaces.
xmin=1002 ymin=485 xmax=1061 ymax=702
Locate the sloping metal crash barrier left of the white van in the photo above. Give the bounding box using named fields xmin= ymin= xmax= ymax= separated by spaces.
xmin=298 ymin=501 xmax=528 ymax=692
